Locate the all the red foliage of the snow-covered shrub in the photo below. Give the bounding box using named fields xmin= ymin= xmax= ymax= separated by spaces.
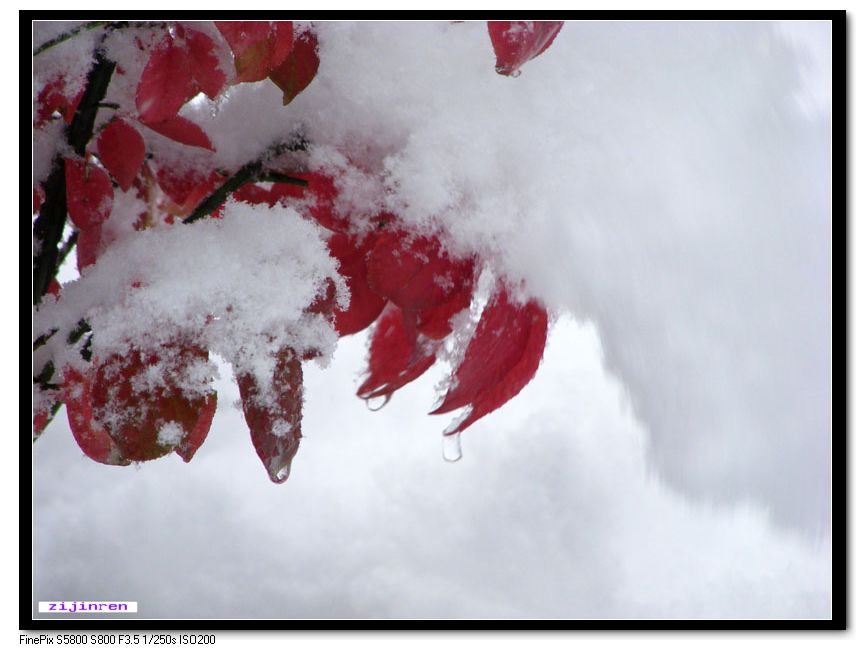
xmin=33 ymin=21 xmax=562 ymax=483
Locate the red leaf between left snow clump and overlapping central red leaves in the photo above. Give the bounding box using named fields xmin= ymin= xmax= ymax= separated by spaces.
xmin=328 ymin=232 xmax=386 ymax=336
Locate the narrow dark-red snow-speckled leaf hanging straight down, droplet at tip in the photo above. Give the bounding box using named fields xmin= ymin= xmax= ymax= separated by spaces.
xmin=237 ymin=348 xmax=303 ymax=483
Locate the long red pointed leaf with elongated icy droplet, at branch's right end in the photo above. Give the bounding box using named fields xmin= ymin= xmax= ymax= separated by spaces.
xmin=432 ymin=287 xmax=547 ymax=426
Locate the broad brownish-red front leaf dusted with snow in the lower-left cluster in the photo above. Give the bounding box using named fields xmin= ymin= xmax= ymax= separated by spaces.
xmin=90 ymin=344 xmax=216 ymax=461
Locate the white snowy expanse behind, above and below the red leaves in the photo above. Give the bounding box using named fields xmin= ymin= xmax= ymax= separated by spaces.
xmin=33 ymin=22 xmax=831 ymax=618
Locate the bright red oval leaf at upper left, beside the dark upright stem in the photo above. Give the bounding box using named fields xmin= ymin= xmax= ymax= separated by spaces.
xmin=135 ymin=40 xmax=196 ymax=124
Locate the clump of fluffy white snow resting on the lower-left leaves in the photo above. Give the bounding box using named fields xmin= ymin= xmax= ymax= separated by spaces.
xmin=36 ymin=203 xmax=344 ymax=384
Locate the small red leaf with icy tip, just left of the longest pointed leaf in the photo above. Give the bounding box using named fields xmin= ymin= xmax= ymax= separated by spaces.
xmin=357 ymin=305 xmax=438 ymax=400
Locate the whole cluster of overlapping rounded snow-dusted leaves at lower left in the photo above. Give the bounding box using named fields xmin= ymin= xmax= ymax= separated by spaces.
xmin=64 ymin=345 xmax=216 ymax=465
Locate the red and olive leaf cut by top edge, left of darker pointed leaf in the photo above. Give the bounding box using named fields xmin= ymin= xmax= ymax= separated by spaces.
xmin=216 ymin=20 xmax=294 ymax=82
